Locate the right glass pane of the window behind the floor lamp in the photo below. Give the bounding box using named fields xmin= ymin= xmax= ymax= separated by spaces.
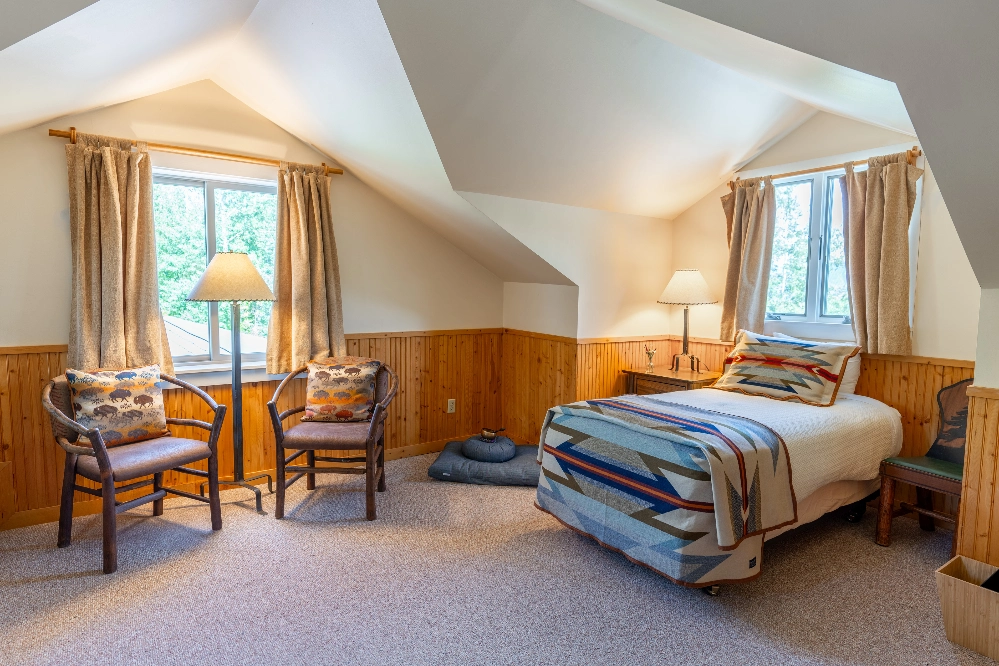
xmin=215 ymin=187 xmax=277 ymax=354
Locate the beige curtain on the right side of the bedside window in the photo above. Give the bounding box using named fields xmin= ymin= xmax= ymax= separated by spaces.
xmin=843 ymin=153 xmax=923 ymax=356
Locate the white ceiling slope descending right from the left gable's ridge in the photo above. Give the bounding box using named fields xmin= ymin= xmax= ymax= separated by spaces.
xmin=212 ymin=0 xmax=572 ymax=285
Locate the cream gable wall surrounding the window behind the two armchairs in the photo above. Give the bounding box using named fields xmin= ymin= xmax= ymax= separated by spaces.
xmin=0 ymin=81 xmax=503 ymax=346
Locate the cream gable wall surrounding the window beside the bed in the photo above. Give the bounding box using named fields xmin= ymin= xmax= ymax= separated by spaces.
xmin=672 ymin=113 xmax=981 ymax=360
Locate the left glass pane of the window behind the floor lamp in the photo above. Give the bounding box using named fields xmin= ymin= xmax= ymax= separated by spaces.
xmin=153 ymin=182 xmax=210 ymax=356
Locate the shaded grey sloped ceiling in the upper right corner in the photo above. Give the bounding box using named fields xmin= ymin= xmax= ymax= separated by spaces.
xmin=648 ymin=0 xmax=999 ymax=286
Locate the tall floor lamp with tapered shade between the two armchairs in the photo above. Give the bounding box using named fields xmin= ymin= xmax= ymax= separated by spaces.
xmin=187 ymin=252 xmax=274 ymax=513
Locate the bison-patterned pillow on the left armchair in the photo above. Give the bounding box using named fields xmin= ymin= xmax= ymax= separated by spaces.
xmin=66 ymin=365 xmax=170 ymax=446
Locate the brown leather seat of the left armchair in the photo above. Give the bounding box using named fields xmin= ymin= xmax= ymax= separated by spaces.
xmin=76 ymin=437 xmax=212 ymax=481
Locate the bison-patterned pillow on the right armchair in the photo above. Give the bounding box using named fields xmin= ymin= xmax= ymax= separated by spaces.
xmin=302 ymin=356 xmax=382 ymax=421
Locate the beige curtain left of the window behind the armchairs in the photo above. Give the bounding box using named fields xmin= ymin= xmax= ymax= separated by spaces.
xmin=66 ymin=133 xmax=173 ymax=373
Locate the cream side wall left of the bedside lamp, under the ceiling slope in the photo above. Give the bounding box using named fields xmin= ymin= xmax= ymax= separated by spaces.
xmin=461 ymin=192 xmax=673 ymax=338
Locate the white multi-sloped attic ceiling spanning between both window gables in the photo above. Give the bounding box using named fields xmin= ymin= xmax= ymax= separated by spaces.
xmin=0 ymin=0 xmax=936 ymax=284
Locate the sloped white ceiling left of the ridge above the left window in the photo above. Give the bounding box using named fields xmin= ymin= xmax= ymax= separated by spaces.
xmin=0 ymin=0 xmax=256 ymax=133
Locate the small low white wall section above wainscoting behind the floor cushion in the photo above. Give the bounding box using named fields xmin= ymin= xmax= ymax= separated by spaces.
xmin=503 ymin=282 xmax=579 ymax=338
